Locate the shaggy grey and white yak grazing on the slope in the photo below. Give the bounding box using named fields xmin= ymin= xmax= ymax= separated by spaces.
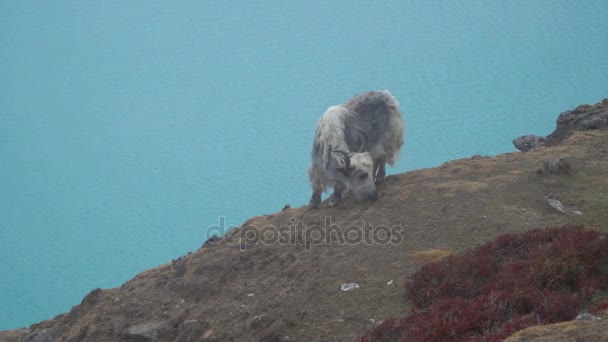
xmin=308 ymin=90 xmax=405 ymax=208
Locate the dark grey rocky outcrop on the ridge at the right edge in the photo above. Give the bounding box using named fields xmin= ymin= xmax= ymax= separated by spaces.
xmin=513 ymin=99 xmax=608 ymax=152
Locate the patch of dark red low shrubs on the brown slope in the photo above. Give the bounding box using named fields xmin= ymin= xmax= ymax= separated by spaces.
xmin=361 ymin=226 xmax=608 ymax=341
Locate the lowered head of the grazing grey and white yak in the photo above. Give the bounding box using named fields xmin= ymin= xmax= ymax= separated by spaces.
xmin=333 ymin=151 xmax=378 ymax=201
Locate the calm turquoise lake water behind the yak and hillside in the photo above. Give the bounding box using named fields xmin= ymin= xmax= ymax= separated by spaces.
xmin=0 ymin=0 xmax=608 ymax=329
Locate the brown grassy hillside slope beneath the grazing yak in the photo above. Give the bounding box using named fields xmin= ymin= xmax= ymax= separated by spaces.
xmin=0 ymin=100 xmax=608 ymax=341
